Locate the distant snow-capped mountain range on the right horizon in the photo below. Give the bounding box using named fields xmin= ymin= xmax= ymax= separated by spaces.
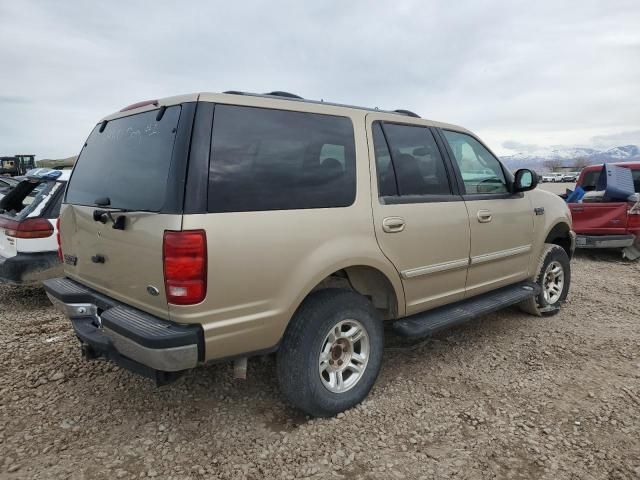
xmin=500 ymin=145 xmax=640 ymax=171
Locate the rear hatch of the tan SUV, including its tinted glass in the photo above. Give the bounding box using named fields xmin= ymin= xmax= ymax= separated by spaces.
xmin=60 ymin=104 xmax=194 ymax=318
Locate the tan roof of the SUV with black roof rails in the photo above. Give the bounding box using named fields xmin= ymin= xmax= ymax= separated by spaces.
xmin=98 ymin=91 xmax=471 ymax=133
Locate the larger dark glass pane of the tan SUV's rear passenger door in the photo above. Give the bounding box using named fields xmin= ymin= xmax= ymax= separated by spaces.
xmin=383 ymin=123 xmax=451 ymax=195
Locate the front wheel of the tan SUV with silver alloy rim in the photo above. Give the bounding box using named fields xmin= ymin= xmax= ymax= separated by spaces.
xmin=519 ymin=243 xmax=571 ymax=317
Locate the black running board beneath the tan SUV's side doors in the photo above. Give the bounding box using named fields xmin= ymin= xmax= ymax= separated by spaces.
xmin=393 ymin=282 xmax=540 ymax=338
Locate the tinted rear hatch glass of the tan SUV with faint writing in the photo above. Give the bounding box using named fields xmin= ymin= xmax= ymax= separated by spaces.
xmin=66 ymin=106 xmax=180 ymax=212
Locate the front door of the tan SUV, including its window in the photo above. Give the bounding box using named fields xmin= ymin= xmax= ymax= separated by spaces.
xmin=441 ymin=130 xmax=534 ymax=297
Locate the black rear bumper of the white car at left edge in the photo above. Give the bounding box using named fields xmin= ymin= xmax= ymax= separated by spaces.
xmin=0 ymin=252 xmax=62 ymax=285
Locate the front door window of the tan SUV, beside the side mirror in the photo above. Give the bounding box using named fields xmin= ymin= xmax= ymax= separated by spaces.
xmin=443 ymin=130 xmax=509 ymax=195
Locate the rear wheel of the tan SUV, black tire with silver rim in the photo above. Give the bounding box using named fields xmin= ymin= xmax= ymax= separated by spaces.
xmin=277 ymin=289 xmax=384 ymax=417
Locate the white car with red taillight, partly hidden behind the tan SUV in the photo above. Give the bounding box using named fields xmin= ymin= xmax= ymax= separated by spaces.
xmin=0 ymin=169 xmax=71 ymax=285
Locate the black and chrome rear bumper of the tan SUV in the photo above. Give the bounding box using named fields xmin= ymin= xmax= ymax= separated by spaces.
xmin=44 ymin=278 xmax=204 ymax=383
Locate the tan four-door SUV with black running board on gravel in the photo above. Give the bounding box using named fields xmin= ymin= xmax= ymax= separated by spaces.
xmin=45 ymin=92 xmax=574 ymax=416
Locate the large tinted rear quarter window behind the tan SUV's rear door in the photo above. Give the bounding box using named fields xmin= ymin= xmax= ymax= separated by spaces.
xmin=208 ymin=105 xmax=356 ymax=212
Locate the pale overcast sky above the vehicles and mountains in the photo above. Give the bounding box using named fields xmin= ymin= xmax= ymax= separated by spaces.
xmin=0 ymin=0 xmax=640 ymax=159
